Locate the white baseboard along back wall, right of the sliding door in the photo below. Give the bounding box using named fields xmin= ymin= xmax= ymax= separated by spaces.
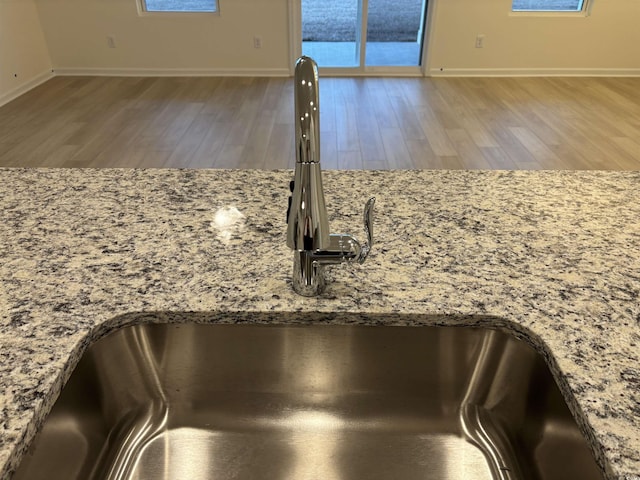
xmin=429 ymin=68 xmax=640 ymax=77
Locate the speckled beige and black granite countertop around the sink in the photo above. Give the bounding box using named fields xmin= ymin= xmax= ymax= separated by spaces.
xmin=0 ymin=169 xmax=640 ymax=479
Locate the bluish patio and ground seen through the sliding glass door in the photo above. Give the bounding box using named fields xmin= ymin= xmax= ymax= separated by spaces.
xmin=301 ymin=0 xmax=427 ymax=70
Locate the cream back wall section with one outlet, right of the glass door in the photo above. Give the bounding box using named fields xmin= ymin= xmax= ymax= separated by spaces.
xmin=429 ymin=0 xmax=640 ymax=75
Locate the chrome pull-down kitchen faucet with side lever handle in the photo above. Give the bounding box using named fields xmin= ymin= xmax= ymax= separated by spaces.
xmin=287 ymin=56 xmax=375 ymax=297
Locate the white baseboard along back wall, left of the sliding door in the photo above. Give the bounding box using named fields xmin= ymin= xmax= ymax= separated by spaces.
xmin=54 ymin=68 xmax=290 ymax=77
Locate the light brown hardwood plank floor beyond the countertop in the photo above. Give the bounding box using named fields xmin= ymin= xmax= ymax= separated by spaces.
xmin=0 ymin=77 xmax=640 ymax=170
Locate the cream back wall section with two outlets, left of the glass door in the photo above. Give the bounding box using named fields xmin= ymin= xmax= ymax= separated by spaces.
xmin=36 ymin=0 xmax=290 ymax=75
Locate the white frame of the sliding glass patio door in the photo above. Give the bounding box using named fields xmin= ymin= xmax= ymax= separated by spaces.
xmin=288 ymin=0 xmax=438 ymax=77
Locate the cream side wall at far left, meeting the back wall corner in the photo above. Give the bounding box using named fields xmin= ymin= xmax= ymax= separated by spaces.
xmin=0 ymin=0 xmax=51 ymax=105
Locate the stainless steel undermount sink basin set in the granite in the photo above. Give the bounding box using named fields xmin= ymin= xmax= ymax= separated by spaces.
xmin=14 ymin=324 xmax=603 ymax=480
